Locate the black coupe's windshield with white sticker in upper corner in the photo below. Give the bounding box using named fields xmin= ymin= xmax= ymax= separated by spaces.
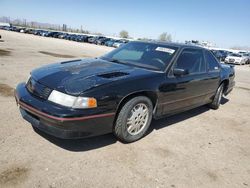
xmin=101 ymin=42 xmax=178 ymax=71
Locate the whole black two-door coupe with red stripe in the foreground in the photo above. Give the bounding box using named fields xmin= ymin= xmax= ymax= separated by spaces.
xmin=15 ymin=42 xmax=235 ymax=142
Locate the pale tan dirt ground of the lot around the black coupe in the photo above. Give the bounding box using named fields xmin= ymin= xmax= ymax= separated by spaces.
xmin=0 ymin=30 xmax=250 ymax=188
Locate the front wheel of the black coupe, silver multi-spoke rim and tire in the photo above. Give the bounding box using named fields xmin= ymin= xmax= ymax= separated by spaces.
xmin=113 ymin=96 xmax=153 ymax=143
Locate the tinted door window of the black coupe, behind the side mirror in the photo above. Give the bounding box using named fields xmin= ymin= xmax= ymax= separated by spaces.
xmin=174 ymin=49 xmax=206 ymax=74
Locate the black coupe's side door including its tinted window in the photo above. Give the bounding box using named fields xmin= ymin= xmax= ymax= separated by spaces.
xmin=161 ymin=48 xmax=209 ymax=115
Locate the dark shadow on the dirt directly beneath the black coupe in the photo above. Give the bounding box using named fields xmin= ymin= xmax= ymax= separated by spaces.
xmin=34 ymin=97 xmax=229 ymax=152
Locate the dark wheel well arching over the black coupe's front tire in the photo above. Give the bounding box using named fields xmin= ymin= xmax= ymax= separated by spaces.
xmin=114 ymin=91 xmax=157 ymax=123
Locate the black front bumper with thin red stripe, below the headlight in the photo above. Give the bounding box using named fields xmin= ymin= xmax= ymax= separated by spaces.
xmin=15 ymin=83 xmax=115 ymax=139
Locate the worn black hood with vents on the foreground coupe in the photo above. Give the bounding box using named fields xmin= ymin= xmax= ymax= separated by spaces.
xmin=31 ymin=59 xmax=150 ymax=95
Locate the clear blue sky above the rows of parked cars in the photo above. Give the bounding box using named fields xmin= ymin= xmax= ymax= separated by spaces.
xmin=0 ymin=0 xmax=250 ymax=47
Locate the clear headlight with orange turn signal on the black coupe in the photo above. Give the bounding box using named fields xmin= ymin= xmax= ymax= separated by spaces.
xmin=48 ymin=90 xmax=97 ymax=108
